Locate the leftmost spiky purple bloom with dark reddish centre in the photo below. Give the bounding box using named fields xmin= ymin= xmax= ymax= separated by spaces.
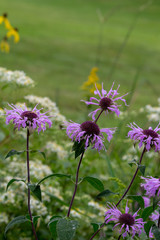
xmin=5 ymin=104 xmax=52 ymax=133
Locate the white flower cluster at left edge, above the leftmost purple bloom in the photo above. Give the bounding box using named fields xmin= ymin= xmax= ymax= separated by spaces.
xmin=0 ymin=67 xmax=34 ymax=87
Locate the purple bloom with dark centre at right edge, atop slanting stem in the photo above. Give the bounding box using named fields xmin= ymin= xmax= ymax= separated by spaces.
xmin=128 ymin=123 xmax=160 ymax=152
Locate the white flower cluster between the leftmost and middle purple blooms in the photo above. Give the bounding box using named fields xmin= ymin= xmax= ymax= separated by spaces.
xmin=25 ymin=95 xmax=66 ymax=122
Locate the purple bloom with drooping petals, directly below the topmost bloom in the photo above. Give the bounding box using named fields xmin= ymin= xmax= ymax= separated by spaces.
xmin=65 ymin=121 xmax=115 ymax=151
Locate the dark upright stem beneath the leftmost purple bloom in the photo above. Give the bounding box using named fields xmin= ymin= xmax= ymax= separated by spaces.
xmin=27 ymin=128 xmax=38 ymax=240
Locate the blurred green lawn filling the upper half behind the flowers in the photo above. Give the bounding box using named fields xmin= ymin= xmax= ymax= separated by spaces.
xmin=0 ymin=0 xmax=160 ymax=120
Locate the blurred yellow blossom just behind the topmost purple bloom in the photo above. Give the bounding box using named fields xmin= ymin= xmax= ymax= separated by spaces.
xmin=81 ymin=67 xmax=101 ymax=93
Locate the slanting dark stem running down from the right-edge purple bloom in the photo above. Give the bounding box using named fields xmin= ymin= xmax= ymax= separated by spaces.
xmin=89 ymin=147 xmax=146 ymax=240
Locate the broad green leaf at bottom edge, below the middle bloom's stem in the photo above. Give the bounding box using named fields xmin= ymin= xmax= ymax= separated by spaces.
xmin=57 ymin=218 xmax=78 ymax=240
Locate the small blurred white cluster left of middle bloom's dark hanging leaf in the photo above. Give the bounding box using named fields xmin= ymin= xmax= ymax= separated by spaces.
xmin=45 ymin=141 xmax=68 ymax=160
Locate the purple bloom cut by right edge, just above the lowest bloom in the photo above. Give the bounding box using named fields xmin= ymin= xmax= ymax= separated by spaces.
xmin=141 ymin=176 xmax=160 ymax=197
